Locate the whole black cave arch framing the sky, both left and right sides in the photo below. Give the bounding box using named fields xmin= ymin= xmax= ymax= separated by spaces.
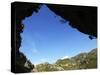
xmin=11 ymin=2 xmax=97 ymax=73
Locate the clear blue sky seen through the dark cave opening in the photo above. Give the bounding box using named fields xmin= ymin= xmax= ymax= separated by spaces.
xmin=20 ymin=5 xmax=97 ymax=64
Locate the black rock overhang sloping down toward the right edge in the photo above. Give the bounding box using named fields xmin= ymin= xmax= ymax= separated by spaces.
xmin=47 ymin=4 xmax=97 ymax=37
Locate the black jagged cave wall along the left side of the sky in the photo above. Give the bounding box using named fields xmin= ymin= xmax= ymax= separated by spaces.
xmin=11 ymin=2 xmax=39 ymax=73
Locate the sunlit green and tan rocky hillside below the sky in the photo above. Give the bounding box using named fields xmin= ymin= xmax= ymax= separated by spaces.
xmin=36 ymin=49 xmax=97 ymax=72
